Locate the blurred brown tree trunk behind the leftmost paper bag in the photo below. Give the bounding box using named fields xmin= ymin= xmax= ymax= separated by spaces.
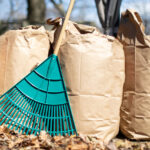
xmin=27 ymin=0 xmax=46 ymax=24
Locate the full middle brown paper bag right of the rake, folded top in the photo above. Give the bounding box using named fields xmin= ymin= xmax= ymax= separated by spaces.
xmin=52 ymin=22 xmax=124 ymax=143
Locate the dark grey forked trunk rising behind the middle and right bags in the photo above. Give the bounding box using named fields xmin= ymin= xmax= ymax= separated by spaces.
xmin=95 ymin=0 xmax=122 ymax=36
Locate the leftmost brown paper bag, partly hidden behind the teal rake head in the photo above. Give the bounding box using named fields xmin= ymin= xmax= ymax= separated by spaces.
xmin=0 ymin=26 xmax=50 ymax=95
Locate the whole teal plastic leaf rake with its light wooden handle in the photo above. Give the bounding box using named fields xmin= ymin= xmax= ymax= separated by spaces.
xmin=0 ymin=0 xmax=77 ymax=136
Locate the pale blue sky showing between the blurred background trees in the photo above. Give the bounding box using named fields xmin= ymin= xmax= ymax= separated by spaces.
xmin=0 ymin=0 xmax=150 ymax=26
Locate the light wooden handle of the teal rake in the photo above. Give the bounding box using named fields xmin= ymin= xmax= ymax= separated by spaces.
xmin=54 ymin=0 xmax=75 ymax=56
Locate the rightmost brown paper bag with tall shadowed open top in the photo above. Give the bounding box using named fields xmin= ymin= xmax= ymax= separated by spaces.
xmin=118 ymin=10 xmax=150 ymax=139
